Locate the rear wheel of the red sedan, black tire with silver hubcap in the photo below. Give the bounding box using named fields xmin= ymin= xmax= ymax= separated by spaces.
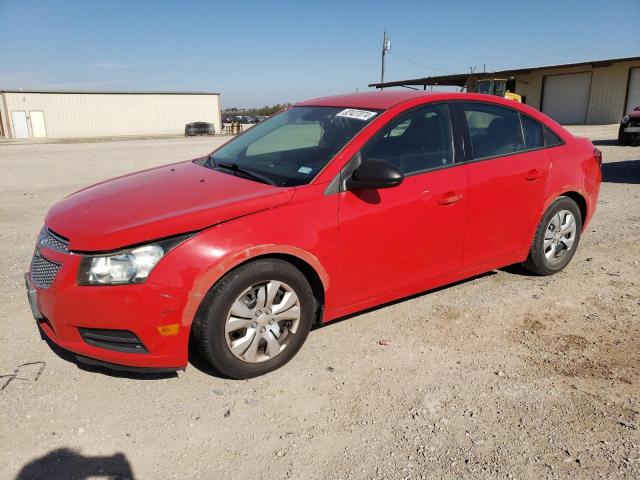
xmin=522 ymin=197 xmax=582 ymax=275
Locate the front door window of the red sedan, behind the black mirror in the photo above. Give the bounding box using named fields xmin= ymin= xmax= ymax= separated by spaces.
xmin=361 ymin=104 xmax=453 ymax=175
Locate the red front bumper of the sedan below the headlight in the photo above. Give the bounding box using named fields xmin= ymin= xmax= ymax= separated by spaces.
xmin=25 ymin=244 xmax=191 ymax=371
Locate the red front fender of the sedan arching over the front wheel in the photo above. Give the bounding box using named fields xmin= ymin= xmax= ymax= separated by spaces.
xmin=148 ymin=186 xmax=338 ymax=326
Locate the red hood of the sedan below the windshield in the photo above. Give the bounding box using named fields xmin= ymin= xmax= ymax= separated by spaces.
xmin=45 ymin=161 xmax=294 ymax=252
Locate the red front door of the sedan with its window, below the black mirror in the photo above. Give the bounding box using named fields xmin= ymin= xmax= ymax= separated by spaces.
xmin=338 ymin=104 xmax=467 ymax=305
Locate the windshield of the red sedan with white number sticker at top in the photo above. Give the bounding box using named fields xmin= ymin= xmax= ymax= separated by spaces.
xmin=204 ymin=107 xmax=380 ymax=186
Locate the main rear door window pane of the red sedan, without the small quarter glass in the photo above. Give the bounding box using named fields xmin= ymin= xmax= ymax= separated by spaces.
xmin=462 ymin=103 xmax=524 ymax=159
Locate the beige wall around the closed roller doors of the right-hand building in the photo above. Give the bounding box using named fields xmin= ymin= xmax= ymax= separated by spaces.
xmin=516 ymin=61 xmax=640 ymax=124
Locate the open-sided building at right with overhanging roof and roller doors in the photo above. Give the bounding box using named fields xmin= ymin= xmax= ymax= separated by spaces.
xmin=369 ymin=57 xmax=640 ymax=124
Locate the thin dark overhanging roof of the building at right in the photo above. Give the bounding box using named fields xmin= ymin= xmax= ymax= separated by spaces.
xmin=369 ymin=57 xmax=640 ymax=88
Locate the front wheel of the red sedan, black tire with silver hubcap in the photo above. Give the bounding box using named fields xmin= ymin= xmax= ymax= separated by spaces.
xmin=192 ymin=259 xmax=317 ymax=379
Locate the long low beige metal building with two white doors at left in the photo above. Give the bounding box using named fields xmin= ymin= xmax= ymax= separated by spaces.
xmin=0 ymin=90 xmax=221 ymax=139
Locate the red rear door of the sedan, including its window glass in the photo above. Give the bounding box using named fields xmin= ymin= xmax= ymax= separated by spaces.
xmin=459 ymin=102 xmax=551 ymax=268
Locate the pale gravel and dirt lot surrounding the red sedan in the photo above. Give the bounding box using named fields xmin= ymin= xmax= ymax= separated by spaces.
xmin=0 ymin=126 xmax=640 ymax=479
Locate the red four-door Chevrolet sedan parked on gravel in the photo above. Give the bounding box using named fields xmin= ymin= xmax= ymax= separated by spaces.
xmin=26 ymin=91 xmax=601 ymax=378
